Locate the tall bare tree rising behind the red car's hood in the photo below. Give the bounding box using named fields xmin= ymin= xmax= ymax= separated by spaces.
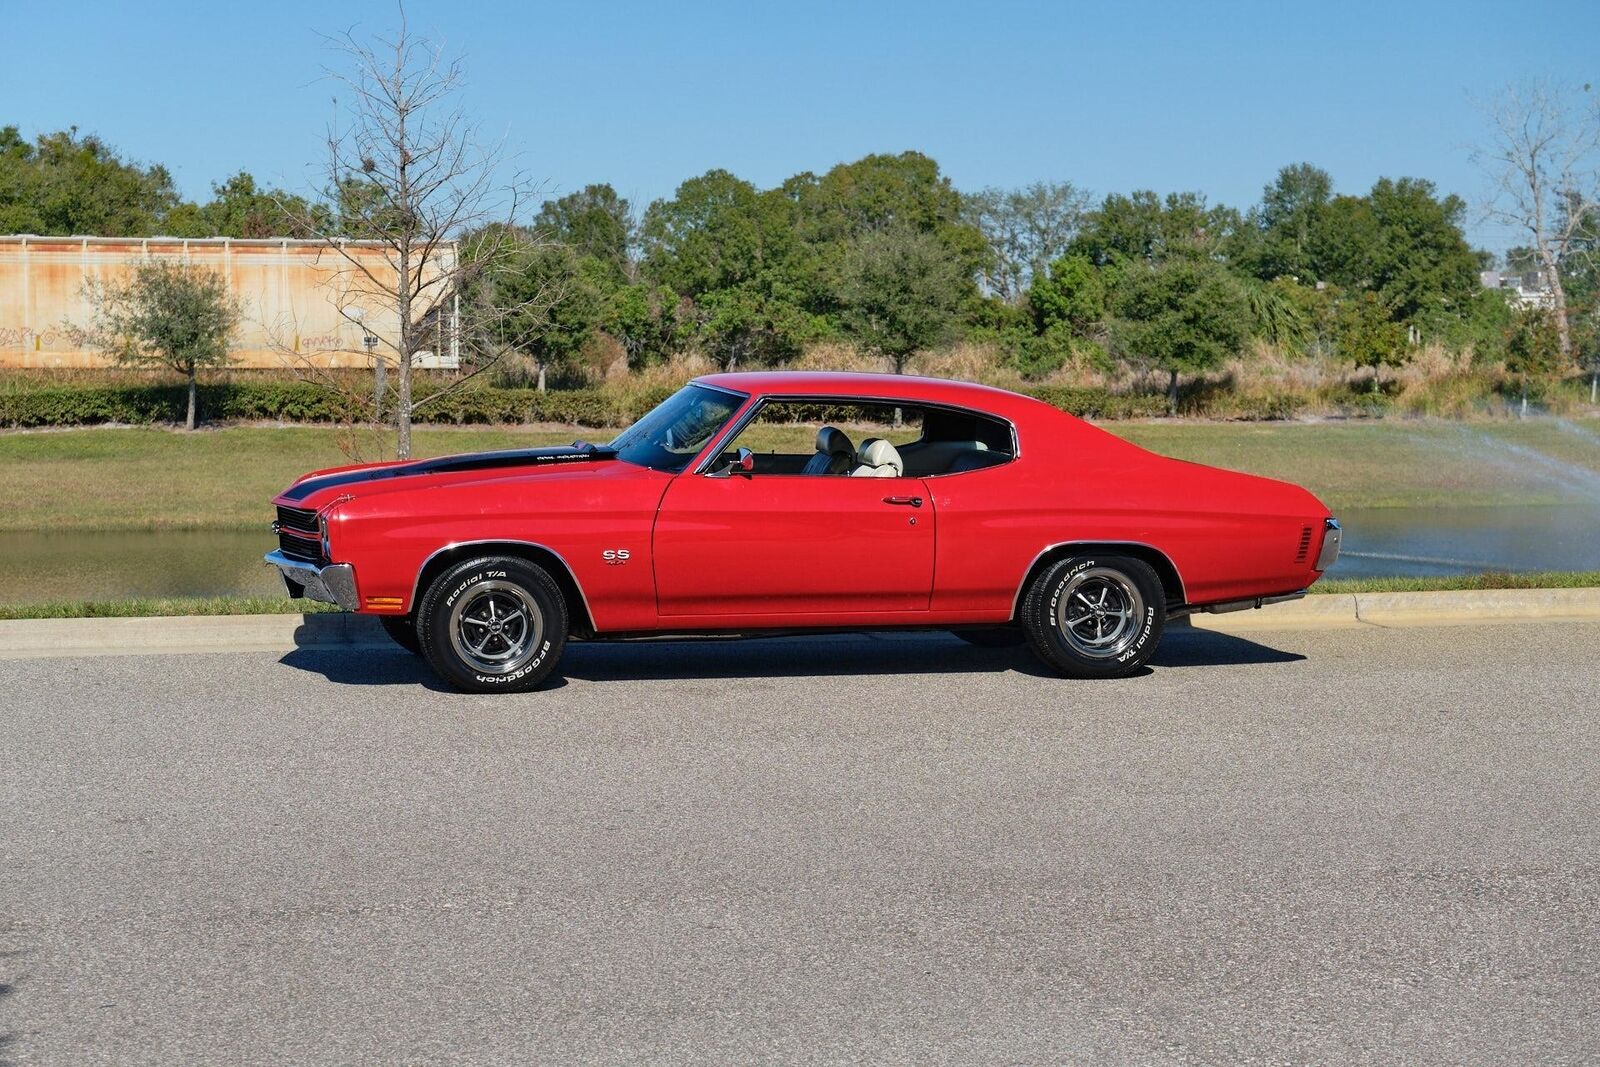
xmin=284 ymin=10 xmax=555 ymax=459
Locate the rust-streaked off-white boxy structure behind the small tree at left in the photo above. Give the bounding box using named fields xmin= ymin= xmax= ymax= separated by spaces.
xmin=0 ymin=235 xmax=459 ymax=368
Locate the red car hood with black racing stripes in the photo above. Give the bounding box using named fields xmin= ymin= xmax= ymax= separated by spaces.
xmin=275 ymin=445 xmax=616 ymax=510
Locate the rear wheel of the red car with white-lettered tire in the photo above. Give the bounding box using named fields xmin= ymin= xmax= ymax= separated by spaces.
xmin=1019 ymin=555 xmax=1166 ymax=678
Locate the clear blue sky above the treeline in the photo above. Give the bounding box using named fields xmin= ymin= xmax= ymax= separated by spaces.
xmin=0 ymin=0 xmax=1600 ymax=246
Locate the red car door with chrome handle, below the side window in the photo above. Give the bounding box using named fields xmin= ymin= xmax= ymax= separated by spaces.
xmin=653 ymin=472 xmax=936 ymax=625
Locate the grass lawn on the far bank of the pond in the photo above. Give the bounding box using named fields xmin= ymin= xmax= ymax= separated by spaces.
xmin=0 ymin=419 xmax=1600 ymax=531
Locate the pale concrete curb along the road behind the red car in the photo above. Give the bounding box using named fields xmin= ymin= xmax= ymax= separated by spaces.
xmin=0 ymin=589 xmax=1600 ymax=659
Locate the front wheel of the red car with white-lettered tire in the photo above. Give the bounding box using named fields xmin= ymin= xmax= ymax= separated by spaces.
xmin=416 ymin=557 xmax=568 ymax=693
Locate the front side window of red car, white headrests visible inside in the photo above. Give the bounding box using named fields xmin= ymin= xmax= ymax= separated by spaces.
xmin=710 ymin=398 xmax=923 ymax=478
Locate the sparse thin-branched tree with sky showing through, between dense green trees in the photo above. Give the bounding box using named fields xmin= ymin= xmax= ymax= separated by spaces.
xmin=963 ymin=182 xmax=1090 ymax=304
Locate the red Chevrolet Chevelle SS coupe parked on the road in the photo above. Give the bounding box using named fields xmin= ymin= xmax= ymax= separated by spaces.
xmin=267 ymin=371 xmax=1341 ymax=693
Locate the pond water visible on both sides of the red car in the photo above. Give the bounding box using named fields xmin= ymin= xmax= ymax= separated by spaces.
xmin=0 ymin=504 xmax=1600 ymax=603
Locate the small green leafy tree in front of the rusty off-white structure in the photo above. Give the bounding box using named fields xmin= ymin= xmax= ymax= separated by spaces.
xmin=67 ymin=259 xmax=240 ymax=430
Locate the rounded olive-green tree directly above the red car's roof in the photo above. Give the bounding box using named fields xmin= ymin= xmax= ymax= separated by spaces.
xmin=838 ymin=226 xmax=973 ymax=374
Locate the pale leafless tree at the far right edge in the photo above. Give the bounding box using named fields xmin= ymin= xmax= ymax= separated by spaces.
xmin=1474 ymin=82 xmax=1600 ymax=366
